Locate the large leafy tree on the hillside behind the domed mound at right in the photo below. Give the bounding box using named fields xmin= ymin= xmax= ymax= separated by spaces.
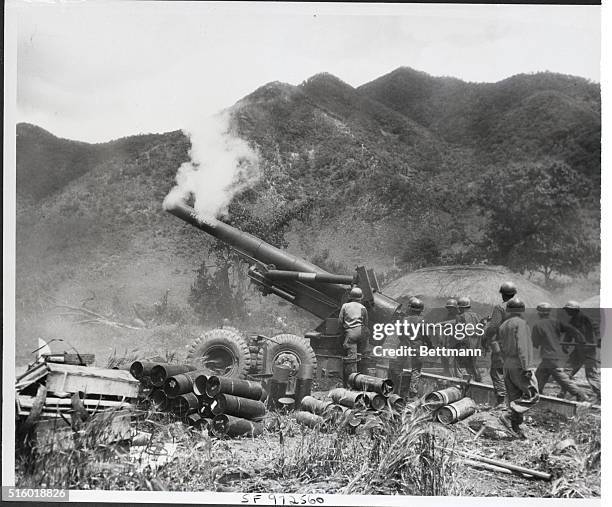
xmin=475 ymin=160 xmax=599 ymax=284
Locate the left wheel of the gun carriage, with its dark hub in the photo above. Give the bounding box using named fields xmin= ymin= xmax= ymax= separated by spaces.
xmin=187 ymin=328 xmax=252 ymax=378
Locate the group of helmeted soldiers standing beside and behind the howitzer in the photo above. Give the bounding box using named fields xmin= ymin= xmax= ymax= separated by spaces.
xmin=339 ymin=282 xmax=601 ymax=438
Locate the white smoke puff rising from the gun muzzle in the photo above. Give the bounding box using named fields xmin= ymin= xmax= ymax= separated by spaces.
xmin=163 ymin=113 xmax=259 ymax=217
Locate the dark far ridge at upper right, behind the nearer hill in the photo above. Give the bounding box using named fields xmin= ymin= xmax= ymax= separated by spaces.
xmin=359 ymin=67 xmax=601 ymax=186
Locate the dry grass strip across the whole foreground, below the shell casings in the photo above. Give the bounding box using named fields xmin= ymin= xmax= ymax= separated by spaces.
xmin=17 ymin=396 xmax=601 ymax=498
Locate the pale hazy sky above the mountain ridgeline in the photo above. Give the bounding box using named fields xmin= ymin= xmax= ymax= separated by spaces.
xmin=6 ymin=0 xmax=600 ymax=141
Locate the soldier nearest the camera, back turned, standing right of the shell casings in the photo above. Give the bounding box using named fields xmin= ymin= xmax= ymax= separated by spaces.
xmin=497 ymin=297 xmax=539 ymax=439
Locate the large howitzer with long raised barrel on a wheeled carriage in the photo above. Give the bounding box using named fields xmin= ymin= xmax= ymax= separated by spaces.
xmin=165 ymin=202 xmax=401 ymax=382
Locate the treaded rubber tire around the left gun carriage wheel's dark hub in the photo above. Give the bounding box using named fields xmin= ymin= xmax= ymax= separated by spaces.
xmin=187 ymin=327 xmax=253 ymax=379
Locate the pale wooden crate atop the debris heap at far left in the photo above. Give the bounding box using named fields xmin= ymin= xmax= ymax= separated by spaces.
xmin=47 ymin=363 xmax=139 ymax=398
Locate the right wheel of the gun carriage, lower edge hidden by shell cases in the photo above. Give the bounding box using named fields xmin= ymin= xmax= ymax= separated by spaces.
xmin=257 ymin=334 xmax=317 ymax=376
